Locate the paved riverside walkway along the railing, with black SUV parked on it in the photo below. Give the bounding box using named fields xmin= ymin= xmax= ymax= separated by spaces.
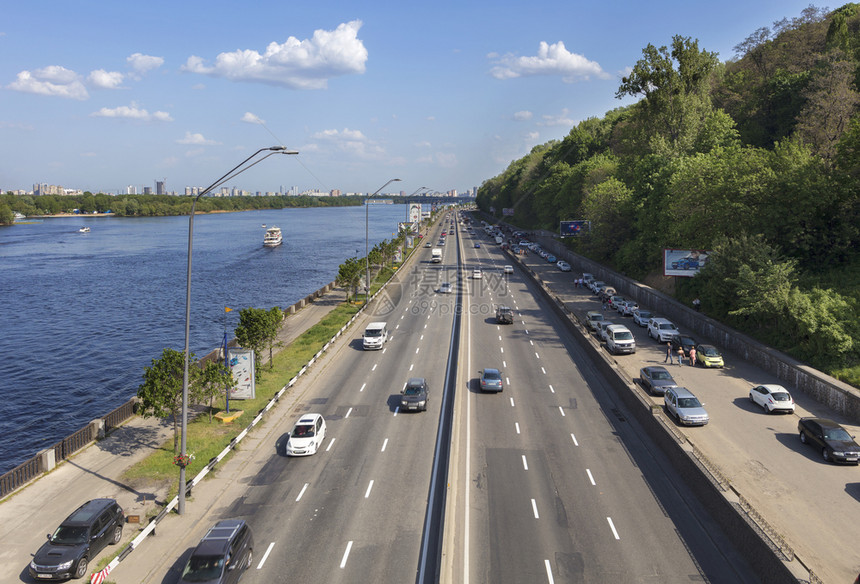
xmin=0 ymin=289 xmax=346 ymax=583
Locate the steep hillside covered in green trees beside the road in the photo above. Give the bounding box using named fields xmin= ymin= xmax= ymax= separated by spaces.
xmin=477 ymin=4 xmax=860 ymax=384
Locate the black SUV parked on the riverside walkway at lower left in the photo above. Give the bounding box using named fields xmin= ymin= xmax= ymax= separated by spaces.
xmin=30 ymin=499 xmax=125 ymax=580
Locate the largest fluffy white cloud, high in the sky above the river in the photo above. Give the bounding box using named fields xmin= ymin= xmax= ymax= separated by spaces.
xmin=182 ymin=20 xmax=367 ymax=89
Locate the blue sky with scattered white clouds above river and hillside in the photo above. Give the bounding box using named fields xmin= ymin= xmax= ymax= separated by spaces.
xmin=0 ymin=0 xmax=820 ymax=194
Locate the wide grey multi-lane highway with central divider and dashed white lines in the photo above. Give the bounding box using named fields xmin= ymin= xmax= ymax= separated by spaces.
xmin=129 ymin=215 xmax=757 ymax=584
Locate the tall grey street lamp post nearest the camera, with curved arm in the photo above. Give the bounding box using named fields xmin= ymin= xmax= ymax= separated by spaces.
xmin=177 ymin=146 xmax=298 ymax=515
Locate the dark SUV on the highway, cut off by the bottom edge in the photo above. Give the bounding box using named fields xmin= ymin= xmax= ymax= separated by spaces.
xmin=179 ymin=519 xmax=254 ymax=584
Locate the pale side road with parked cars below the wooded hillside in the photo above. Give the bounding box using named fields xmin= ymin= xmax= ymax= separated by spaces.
xmin=510 ymin=225 xmax=860 ymax=582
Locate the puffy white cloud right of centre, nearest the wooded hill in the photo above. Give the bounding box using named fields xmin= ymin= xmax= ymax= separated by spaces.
xmin=489 ymin=41 xmax=609 ymax=83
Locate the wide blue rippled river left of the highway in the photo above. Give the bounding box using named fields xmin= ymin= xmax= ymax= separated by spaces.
xmin=0 ymin=205 xmax=406 ymax=474
